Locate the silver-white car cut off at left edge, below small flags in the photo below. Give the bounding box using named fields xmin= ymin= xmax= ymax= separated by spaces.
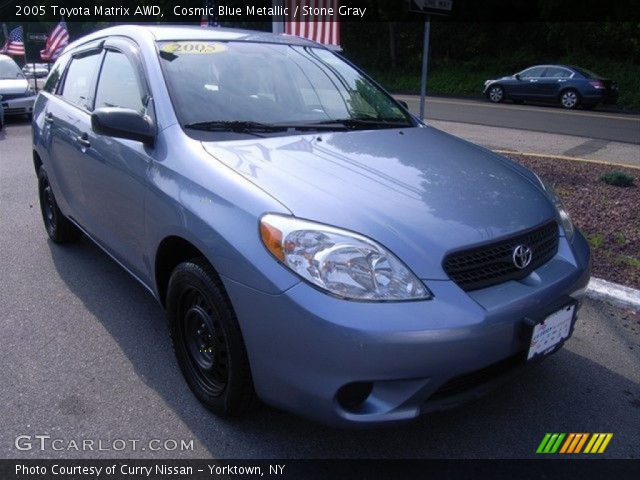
xmin=0 ymin=55 xmax=36 ymax=115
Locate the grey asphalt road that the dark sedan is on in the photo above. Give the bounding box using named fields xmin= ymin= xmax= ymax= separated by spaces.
xmin=395 ymin=95 xmax=640 ymax=144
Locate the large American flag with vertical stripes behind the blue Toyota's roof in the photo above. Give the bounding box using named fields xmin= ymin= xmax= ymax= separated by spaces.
xmin=284 ymin=0 xmax=340 ymax=46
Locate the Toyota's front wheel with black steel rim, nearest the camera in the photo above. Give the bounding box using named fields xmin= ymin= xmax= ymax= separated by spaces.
xmin=167 ymin=258 xmax=258 ymax=416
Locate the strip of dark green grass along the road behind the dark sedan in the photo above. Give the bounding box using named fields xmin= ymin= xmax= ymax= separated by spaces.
xmin=369 ymin=58 xmax=640 ymax=110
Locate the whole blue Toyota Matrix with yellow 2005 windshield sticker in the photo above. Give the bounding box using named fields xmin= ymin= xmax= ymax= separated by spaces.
xmin=33 ymin=26 xmax=590 ymax=425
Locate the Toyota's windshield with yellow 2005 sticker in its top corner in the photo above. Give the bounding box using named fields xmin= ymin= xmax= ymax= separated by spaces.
xmin=158 ymin=41 xmax=413 ymax=128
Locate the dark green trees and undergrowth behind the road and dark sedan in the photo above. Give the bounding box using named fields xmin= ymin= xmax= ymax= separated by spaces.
xmin=342 ymin=19 xmax=640 ymax=109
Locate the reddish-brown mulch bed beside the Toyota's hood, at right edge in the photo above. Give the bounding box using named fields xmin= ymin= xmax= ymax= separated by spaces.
xmin=507 ymin=154 xmax=640 ymax=288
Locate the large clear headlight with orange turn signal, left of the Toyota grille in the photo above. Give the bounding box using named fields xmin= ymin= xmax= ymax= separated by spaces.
xmin=260 ymin=214 xmax=432 ymax=301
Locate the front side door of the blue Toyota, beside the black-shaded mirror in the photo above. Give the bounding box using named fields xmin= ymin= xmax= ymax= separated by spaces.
xmin=79 ymin=38 xmax=153 ymax=280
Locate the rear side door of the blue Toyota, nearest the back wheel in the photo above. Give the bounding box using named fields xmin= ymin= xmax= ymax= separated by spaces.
xmin=44 ymin=47 xmax=102 ymax=225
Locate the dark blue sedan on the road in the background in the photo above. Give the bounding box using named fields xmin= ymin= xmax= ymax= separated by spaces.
xmin=483 ymin=65 xmax=618 ymax=109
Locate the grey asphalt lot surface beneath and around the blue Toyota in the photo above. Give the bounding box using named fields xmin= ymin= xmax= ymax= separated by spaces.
xmin=0 ymin=121 xmax=640 ymax=459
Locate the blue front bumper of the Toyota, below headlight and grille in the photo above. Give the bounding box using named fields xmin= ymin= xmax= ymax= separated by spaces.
xmin=224 ymin=232 xmax=590 ymax=425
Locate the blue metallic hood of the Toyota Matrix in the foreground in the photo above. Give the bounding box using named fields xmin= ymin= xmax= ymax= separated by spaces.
xmin=203 ymin=127 xmax=556 ymax=279
